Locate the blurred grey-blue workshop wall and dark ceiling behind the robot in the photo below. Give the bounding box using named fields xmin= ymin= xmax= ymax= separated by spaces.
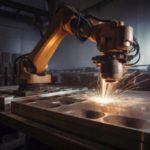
xmin=0 ymin=0 xmax=150 ymax=89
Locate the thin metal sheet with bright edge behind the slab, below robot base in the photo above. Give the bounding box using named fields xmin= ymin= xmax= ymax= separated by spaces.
xmin=0 ymin=86 xmax=87 ymax=111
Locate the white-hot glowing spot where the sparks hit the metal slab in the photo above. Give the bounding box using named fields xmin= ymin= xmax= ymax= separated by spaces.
xmin=89 ymin=96 xmax=113 ymax=104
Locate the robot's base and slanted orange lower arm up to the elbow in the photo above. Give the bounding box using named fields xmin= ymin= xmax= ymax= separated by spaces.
xmin=15 ymin=6 xmax=78 ymax=86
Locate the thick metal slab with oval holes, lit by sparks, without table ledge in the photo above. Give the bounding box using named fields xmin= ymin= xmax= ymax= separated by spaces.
xmin=12 ymin=89 xmax=150 ymax=149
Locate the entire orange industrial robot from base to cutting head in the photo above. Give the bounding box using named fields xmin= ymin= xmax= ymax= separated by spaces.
xmin=15 ymin=5 xmax=140 ymax=92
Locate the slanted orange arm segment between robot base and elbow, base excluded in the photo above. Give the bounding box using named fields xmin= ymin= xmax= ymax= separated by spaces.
xmin=31 ymin=7 xmax=75 ymax=74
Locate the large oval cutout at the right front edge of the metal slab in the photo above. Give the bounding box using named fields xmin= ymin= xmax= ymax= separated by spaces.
xmin=104 ymin=116 xmax=150 ymax=129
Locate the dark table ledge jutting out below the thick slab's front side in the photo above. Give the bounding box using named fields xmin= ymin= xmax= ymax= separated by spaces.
xmin=0 ymin=112 xmax=114 ymax=150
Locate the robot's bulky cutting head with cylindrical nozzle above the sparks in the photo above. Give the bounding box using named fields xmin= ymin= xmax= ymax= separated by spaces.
xmin=92 ymin=22 xmax=139 ymax=82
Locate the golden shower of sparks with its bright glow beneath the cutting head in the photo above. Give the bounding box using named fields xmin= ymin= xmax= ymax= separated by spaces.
xmin=88 ymin=72 xmax=149 ymax=104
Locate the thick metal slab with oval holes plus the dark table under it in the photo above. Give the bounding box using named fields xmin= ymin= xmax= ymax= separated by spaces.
xmin=0 ymin=91 xmax=150 ymax=150
